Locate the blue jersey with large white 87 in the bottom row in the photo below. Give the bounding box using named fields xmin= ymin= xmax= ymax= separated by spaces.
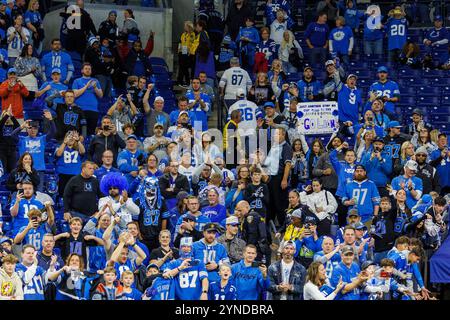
xmin=167 ymin=259 xmax=208 ymax=300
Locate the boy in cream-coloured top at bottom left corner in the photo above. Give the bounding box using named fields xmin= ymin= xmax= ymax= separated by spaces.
xmin=0 ymin=254 xmax=23 ymax=300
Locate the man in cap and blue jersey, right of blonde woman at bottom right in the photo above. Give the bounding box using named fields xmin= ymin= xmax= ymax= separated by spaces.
xmin=330 ymin=245 xmax=369 ymax=300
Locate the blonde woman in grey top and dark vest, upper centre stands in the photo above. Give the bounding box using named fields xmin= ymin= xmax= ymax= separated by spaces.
xmin=278 ymin=30 xmax=303 ymax=73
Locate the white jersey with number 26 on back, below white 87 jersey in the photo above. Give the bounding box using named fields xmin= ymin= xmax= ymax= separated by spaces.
xmin=228 ymin=100 xmax=264 ymax=136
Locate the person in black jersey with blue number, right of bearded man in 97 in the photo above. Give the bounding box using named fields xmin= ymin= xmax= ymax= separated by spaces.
xmin=370 ymin=197 xmax=397 ymax=264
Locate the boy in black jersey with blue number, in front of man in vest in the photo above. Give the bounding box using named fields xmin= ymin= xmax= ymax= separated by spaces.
xmin=245 ymin=168 xmax=269 ymax=218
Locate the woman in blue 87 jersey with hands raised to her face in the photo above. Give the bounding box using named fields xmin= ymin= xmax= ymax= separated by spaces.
xmin=55 ymin=131 xmax=86 ymax=195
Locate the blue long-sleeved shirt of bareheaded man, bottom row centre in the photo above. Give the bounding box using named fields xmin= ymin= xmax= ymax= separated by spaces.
xmin=231 ymin=260 xmax=269 ymax=300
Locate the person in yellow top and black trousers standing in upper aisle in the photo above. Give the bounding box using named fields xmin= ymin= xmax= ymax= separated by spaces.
xmin=177 ymin=21 xmax=195 ymax=87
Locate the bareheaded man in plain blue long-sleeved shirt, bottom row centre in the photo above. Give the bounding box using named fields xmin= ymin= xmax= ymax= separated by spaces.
xmin=231 ymin=244 xmax=269 ymax=300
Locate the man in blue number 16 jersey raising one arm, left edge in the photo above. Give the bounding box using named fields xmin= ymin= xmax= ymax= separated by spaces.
xmin=14 ymin=202 xmax=55 ymax=251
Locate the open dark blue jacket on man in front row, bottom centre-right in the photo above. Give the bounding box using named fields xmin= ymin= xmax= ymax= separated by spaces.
xmin=267 ymin=261 xmax=306 ymax=300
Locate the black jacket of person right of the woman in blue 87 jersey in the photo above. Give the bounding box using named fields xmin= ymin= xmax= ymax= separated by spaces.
xmin=88 ymin=134 xmax=125 ymax=166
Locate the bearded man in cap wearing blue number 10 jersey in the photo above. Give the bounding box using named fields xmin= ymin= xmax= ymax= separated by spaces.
xmin=192 ymin=223 xmax=230 ymax=282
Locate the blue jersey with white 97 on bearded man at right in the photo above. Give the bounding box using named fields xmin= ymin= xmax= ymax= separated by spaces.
xmin=342 ymin=180 xmax=380 ymax=223
